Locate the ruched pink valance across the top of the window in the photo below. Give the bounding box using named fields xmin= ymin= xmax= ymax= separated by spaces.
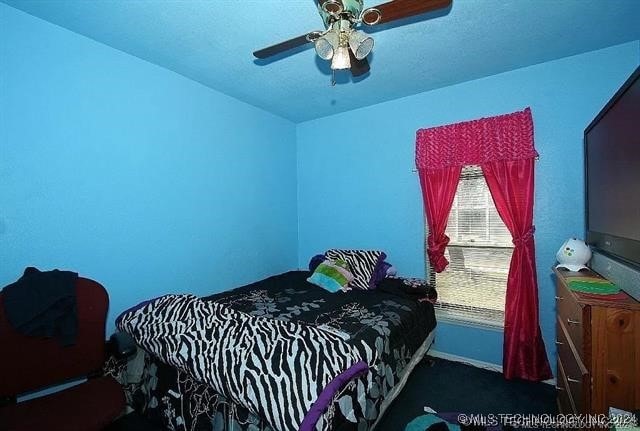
xmin=416 ymin=108 xmax=538 ymax=170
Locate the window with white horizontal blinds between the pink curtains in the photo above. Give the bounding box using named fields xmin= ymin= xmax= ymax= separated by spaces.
xmin=431 ymin=166 xmax=513 ymax=327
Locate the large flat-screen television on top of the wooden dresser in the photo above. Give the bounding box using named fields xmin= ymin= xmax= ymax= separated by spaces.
xmin=584 ymin=67 xmax=640 ymax=268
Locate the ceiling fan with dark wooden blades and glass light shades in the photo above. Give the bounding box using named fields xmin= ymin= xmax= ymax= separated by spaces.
xmin=253 ymin=0 xmax=452 ymax=84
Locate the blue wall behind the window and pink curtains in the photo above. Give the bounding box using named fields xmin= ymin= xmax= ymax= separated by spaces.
xmin=297 ymin=42 xmax=638 ymax=365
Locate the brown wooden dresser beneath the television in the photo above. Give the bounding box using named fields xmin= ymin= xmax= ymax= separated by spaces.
xmin=554 ymin=269 xmax=640 ymax=413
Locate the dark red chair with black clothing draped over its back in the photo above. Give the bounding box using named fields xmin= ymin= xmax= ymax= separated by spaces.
xmin=0 ymin=277 xmax=125 ymax=431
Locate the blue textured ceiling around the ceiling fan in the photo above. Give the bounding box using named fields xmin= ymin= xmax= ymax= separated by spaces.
xmin=1 ymin=0 xmax=640 ymax=122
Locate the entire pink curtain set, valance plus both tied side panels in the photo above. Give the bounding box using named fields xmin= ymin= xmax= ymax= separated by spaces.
xmin=416 ymin=108 xmax=551 ymax=380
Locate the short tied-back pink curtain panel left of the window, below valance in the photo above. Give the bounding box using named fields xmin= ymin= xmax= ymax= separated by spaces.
xmin=419 ymin=166 xmax=462 ymax=272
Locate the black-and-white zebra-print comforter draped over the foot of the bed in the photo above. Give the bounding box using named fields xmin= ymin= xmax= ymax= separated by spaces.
xmin=117 ymin=295 xmax=373 ymax=431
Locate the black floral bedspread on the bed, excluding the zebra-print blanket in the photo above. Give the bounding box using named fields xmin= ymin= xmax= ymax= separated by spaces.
xmin=106 ymin=271 xmax=436 ymax=431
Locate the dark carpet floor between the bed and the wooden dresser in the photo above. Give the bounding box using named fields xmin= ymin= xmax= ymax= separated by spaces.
xmin=378 ymin=357 xmax=556 ymax=431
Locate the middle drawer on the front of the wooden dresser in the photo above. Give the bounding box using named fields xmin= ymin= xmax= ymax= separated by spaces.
xmin=556 ymin=316 xmax=591 ymax=413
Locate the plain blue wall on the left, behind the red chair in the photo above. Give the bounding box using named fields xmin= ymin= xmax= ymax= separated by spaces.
xmin=0 ymin=4 xmax=297 ymax=330
